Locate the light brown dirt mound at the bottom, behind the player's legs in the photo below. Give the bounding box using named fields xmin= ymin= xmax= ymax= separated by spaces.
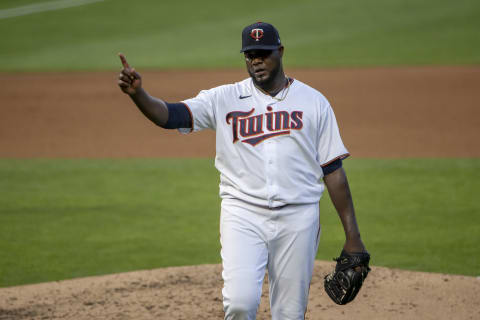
xmin=0 ymin=261 xmax=480 ymax=320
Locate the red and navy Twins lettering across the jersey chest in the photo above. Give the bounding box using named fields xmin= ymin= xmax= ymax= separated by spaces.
xmin=225 ymin=106 xmax=303 ymax=146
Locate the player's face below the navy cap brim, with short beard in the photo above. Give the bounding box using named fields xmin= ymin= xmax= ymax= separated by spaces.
xmin=244 ymin=47 xmax=283 ymax=88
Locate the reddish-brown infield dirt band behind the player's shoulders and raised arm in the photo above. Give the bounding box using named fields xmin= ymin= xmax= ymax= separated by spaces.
xmin=0 ymin=67 xmax=480 ymax=158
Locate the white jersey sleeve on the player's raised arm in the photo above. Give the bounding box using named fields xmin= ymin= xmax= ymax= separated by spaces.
xmin=179 ymin=89 xmax=216 ymax=133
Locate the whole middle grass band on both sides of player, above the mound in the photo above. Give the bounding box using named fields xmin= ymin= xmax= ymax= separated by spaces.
xmin=0 ymin=159 xmax=480 ymax=286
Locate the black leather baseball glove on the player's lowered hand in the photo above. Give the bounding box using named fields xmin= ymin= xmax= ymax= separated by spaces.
xmin=323 ymin=250 xmax=370 ymax=304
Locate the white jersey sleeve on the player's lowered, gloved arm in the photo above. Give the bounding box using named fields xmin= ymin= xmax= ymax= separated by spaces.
xmin=318 ymin=102 xmax=350 ymax=167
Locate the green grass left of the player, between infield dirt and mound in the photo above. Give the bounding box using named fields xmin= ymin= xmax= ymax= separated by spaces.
xmin=0 ymin=160 xmax=220 ymax=286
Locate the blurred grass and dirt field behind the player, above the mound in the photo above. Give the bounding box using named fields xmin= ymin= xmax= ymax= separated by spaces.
xmin=0 ymin=0 xmax=480 ymax=287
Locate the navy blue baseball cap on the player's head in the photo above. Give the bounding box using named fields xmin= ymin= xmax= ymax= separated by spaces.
xmin=240 ymin=22 xmax=282 ymax=52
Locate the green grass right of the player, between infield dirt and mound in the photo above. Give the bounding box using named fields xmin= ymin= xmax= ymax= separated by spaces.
xmin=319 ymin=159 xmax=480 ymax=276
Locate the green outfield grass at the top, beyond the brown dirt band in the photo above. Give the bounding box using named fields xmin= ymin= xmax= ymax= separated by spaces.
xmin=0 ymin=0 xmax=480 ymax=72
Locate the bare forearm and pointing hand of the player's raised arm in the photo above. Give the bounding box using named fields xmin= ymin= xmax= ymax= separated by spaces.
xmin=118 ymin=53 xmax=168 ymax=127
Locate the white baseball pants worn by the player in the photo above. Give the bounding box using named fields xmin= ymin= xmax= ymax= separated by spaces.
xmin=220 ymin=199 xmax=320 ymax=320
